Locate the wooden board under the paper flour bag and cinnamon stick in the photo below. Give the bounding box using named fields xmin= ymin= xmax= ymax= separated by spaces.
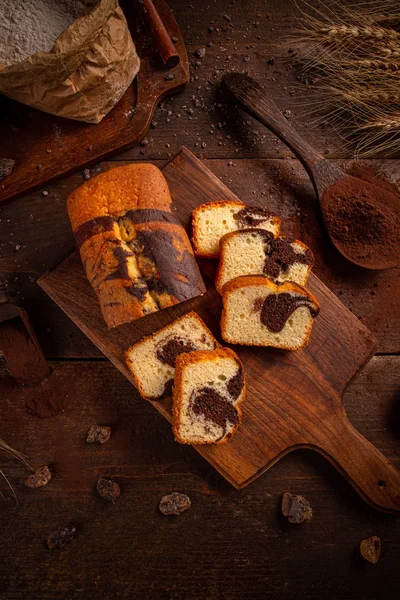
xmin=0 ymin=0 xmax=189 ymax=202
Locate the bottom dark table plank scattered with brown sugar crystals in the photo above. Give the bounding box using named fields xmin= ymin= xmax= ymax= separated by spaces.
xmin=0 ymin=356 xmax=400 ymax=600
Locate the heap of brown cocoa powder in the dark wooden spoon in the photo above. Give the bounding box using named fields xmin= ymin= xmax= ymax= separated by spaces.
xmin=322 ymin=165 xmax=400 ymax=267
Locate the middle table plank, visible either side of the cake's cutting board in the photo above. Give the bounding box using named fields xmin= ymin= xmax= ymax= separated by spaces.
xmin=0 ymin=159 xmax=400 ymax=357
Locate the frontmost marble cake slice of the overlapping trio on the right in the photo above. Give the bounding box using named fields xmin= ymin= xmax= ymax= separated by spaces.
xmin=221 ymin=275 xmax=319 ymax=350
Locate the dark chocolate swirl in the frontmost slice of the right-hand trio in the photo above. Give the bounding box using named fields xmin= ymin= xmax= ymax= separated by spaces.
xmin=254 ymin=292 xmax=319 ymax=333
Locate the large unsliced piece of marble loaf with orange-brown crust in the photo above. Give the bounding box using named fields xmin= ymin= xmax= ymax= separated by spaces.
xmin=67 ymin=164 xmax=205 ymax=327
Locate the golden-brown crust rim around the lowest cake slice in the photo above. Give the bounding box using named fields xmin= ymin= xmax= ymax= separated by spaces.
xmin=172 ymin=348 xmax=246 ymax=446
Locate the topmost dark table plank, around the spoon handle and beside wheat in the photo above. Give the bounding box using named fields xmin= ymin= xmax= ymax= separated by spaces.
xmin=115 ymin=0 xmax=400 ymax=159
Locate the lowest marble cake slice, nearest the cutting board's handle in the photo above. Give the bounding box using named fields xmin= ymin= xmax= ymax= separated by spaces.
xmin=172 ymin=348 xmax=246 ymax=444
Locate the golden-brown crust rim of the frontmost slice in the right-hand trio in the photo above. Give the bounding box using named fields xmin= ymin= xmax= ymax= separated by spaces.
xmin=221 ymin=275 xmax=320 ymax=350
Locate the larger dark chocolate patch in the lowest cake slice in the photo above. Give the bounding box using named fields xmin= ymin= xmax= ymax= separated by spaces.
xmin=190 ymin=387 xmax=238 ymax=432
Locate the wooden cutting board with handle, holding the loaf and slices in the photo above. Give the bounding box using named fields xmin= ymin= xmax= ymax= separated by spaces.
xmin=39 ymin=148 xmax=400 ymax=512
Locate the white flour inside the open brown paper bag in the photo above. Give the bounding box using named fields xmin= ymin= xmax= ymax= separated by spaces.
xmin=0 ymin=0 xmax=86 ymax=65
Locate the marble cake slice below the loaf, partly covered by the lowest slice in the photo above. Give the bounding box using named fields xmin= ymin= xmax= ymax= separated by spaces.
xmin=125 ymin=312 xmax=219 ymax=400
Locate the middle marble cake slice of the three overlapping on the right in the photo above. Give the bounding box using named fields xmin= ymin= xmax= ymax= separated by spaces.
xmin=215 ymin=229 xmax=314 ymax=293
